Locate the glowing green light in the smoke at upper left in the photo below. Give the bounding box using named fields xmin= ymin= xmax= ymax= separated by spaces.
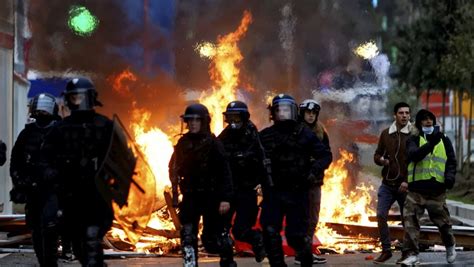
xmin=68 ymin=6 xmax=99 ymax=36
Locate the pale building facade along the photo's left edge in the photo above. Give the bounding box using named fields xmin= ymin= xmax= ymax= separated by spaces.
xmin=0 ymin=0 xmax=29 ymax=214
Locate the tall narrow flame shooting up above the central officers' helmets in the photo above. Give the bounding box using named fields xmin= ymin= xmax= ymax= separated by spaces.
xmin=196 ymin=11 xmax=252 ymax=134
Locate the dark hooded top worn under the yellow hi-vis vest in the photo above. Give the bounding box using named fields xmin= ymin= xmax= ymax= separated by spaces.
xmin=406 ymin=109 xmax=456 ymax=196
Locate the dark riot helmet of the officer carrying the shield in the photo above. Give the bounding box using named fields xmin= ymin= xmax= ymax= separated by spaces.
xmin=64 ymin=78 xmax=102 ymax=111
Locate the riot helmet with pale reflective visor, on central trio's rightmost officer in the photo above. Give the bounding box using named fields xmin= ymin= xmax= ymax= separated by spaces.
xmin=270 ymin=94 xmax=298 ymax=122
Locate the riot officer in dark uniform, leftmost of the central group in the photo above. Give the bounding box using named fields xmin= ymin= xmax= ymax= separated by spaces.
xmin=170 ymin=104 xmax=237 ymax=266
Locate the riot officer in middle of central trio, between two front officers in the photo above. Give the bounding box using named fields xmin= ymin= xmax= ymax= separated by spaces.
xmin=218 ymin=101 xmax=265 ymax=262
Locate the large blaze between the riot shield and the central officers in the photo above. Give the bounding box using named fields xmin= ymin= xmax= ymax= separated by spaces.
xmin=109 ymin=69 xmax=180 ymax=253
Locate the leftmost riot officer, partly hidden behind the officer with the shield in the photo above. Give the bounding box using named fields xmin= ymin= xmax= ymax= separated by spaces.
xmin=10 ymin=93 xmax=58 ymax=266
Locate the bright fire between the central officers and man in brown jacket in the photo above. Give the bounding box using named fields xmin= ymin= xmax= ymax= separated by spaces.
xmin=316 ymin=149 xmax=376 ymax=252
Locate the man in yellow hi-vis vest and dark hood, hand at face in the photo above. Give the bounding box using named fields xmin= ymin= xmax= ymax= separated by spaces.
xmin=401 ymin=109 xmax=456 ymax=265
